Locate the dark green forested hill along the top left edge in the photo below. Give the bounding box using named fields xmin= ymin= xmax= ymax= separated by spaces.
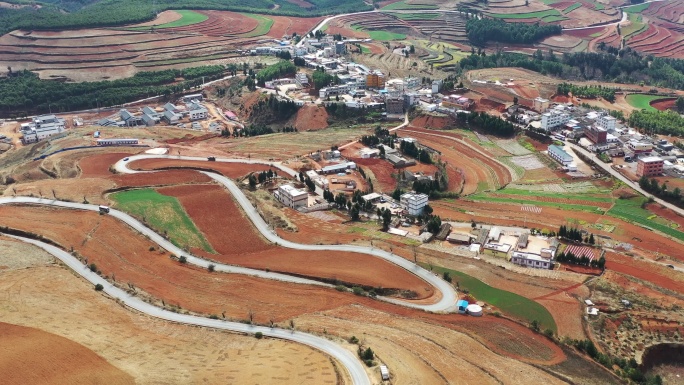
xmin=0 ymin=0 xmax=372 ymax=34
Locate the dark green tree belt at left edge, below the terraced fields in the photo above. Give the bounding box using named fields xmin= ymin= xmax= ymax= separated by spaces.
xmin=0 ymin=66 xmax=226 ymax=117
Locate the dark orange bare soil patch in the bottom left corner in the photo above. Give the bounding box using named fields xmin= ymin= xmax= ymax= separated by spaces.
xmin=0 ymin=322 xmax=135 ymax=385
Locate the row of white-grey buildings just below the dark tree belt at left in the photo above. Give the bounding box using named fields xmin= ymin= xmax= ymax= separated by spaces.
xmin=98 ymin=94 xmax=209 ymax=127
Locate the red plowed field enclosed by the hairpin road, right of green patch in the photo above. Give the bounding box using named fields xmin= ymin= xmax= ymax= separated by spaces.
xmin=158 ymin=185 xmax=434 ymax=292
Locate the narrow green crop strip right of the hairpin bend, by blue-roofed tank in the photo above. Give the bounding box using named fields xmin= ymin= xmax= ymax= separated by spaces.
xmin=421 ymin=263 xmax=558 ymax=333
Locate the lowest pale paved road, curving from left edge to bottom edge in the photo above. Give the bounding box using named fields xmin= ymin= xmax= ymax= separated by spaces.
xmin=1 ymin=231 xmax=371 ymax=385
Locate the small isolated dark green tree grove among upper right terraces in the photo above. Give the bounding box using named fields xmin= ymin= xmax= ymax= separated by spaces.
xmin=466 ymin=18 xmax=562 ymax=46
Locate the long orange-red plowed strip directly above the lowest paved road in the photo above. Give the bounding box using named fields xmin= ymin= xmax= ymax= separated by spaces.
xmin=0 ymin=206 xmax=565 ymax=364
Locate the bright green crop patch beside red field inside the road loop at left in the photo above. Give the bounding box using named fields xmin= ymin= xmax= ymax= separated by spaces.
xmin=111 ymin=189 xmax=215 ymax=253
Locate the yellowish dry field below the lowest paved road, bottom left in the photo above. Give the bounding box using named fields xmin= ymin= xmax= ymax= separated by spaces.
xmin=0 ymin=237 xmax=348 ymax=385
